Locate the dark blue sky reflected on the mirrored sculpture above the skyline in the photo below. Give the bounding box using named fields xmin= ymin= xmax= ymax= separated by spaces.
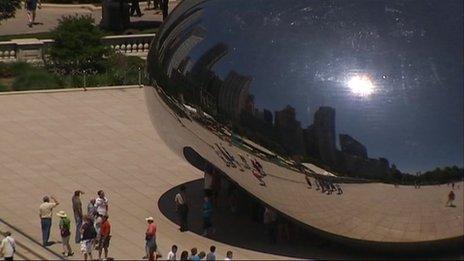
xmin=165 ymin=0 xmax=464 ymax=172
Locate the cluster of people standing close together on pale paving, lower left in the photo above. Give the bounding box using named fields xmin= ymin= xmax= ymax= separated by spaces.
xmin=39 ymin=190 xmax=111 ymax=260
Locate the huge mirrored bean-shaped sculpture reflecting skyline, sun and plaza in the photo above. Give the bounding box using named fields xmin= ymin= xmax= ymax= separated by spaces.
xmin=145 ymin=0 xmax=464 ymax=248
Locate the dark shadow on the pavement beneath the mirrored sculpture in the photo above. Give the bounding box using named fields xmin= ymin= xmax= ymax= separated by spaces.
xmin=158 ymin=179 xmax=368 ymax=258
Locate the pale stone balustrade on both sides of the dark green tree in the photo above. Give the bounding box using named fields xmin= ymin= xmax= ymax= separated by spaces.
xmin=0 ymin=34 xmax=155 ymax=63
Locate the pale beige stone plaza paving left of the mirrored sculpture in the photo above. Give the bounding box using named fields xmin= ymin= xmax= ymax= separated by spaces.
xmin=0 ymin=88 xmax=286 ymax=260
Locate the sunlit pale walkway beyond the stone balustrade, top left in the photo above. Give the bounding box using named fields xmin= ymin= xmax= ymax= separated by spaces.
xmin=0 ymin=1 xmax=177 ymax=35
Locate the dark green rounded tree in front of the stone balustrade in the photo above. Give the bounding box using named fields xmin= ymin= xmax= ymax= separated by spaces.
xmin=47 ymin=15 xmax=109 ymax=74
